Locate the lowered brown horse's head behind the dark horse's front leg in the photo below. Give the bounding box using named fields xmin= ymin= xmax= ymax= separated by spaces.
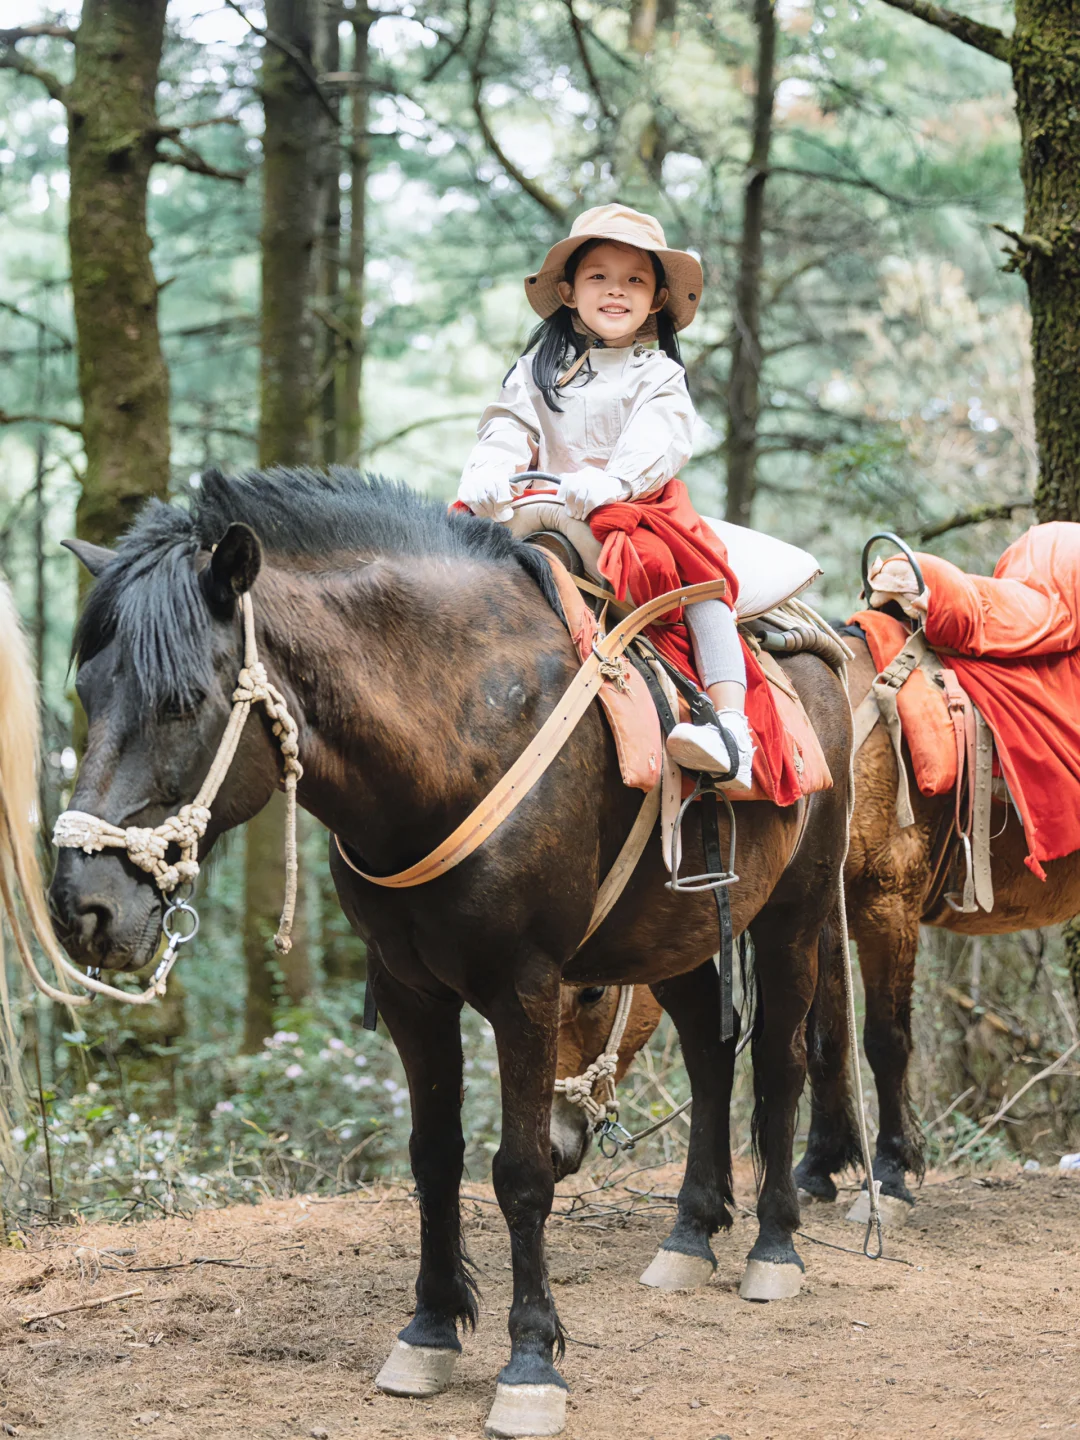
xmin=552 ymin=985 xmax=662 ymax=1179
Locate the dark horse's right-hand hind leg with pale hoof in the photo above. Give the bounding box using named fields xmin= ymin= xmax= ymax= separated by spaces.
xmin=739 ymin=907 xmax=818 ymax=1300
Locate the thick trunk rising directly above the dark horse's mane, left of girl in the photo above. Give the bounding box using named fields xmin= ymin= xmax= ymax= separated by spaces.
xmin=259 ymin=0 xmax=325 ymax=465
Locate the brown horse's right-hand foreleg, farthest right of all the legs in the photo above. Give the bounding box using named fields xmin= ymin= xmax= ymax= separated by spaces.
xmin=857 ymin=896 xmax=924 ymax=1224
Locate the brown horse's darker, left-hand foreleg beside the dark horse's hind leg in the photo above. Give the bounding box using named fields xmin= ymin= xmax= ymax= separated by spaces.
xmin=795 ymin=916 xmax=861 ymax=1201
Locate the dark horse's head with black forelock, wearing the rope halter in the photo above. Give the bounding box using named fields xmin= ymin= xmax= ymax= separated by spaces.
xmin=49 ymin=505 xmax=281 ymax=971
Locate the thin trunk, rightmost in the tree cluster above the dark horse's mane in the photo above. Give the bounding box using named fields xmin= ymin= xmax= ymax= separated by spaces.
xmin=338 ymin=9 xmax=373 ymax=465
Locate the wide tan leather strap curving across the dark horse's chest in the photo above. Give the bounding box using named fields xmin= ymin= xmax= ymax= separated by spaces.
xmin=334 ymin=573 xmax=726 ymax=890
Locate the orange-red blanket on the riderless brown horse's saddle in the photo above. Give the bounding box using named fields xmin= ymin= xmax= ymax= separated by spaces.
xmin=852 ymin=521 xmax=1080 ymax=880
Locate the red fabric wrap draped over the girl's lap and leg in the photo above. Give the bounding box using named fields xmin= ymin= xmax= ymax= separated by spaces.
xmin=589 ymin=480 xmax=802 ymax=805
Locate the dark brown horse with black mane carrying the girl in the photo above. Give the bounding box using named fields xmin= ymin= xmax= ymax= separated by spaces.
xmin=52 ymin=471 xmax=851 ymax=1436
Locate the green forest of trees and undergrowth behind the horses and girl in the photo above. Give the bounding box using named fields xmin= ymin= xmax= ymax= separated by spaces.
xmin=0 ymin=0 xmax=1080 ymax=1214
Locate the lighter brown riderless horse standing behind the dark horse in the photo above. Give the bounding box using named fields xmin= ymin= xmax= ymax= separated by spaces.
xmin=554 ymin=635 xmax=1080 ymax=1224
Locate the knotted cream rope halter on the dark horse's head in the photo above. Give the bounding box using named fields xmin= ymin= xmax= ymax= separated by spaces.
xmin=52 ymin=592 xmax=304 ymax=999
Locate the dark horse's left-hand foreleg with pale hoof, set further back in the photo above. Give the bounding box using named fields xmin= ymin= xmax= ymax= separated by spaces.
xmin=369 ymin=966 xmax=477 ymax=1395
